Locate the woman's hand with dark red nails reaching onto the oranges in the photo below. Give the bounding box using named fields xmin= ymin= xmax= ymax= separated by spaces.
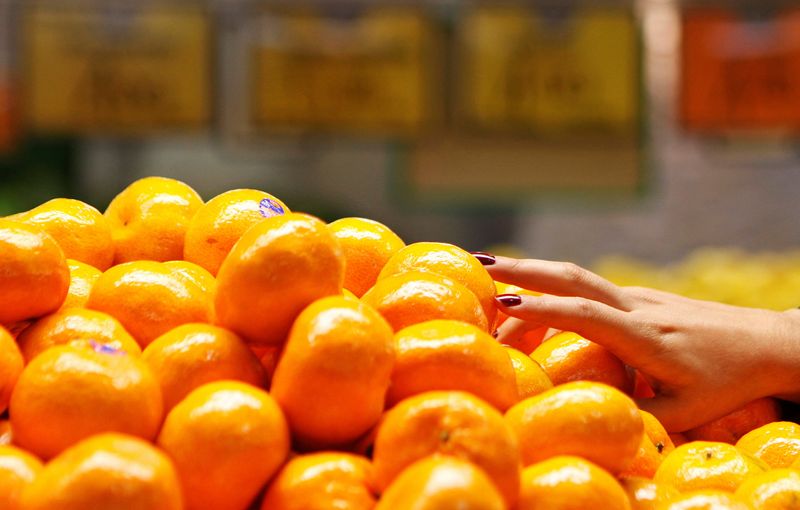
xmin=476 ymin=254 xmax=800 ymax=432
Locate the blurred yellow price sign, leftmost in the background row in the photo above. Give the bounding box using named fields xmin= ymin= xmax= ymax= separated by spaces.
xmin=23 ymin=3 xmax=211 ymax=133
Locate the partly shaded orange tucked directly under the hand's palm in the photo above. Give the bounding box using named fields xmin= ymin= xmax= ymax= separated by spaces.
xmin=531 ymin=331 xmax=633 ymax=393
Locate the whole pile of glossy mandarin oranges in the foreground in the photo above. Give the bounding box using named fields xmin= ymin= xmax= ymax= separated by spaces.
xmin=0 ymin=177 xmax=800 ymax=510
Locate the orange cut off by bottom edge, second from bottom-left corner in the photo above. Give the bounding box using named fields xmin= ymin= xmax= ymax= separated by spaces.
xmin=22 ymin=434 xmax=183 ymax=510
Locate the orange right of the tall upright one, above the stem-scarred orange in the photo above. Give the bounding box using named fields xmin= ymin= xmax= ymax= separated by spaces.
xmin=387 ymin=320 xmax=519 ymax=411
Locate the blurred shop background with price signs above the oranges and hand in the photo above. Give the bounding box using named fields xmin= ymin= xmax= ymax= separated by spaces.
xmin=0 ymin=0 xmax=800 ymax=308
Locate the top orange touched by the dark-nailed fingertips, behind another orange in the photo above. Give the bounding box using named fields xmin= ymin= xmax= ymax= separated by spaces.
xmin=378 ymin=242 xmax=497 ymax=328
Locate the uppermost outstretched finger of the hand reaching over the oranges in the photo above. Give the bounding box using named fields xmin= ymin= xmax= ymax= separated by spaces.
xmin=486 ymin=256 xmax=630 ymax=311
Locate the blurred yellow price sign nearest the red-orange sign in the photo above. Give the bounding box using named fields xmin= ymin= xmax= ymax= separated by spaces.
xmin=459 ymin=6 xmax=640 ymax=134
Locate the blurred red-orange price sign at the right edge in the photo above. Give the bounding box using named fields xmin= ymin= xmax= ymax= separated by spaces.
xmin=681 ymin=8 xmax=800 ymax=132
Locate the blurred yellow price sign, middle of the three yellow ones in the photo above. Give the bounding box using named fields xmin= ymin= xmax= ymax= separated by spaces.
xmin=252 ymin=9 xmax=433 ymax=135
